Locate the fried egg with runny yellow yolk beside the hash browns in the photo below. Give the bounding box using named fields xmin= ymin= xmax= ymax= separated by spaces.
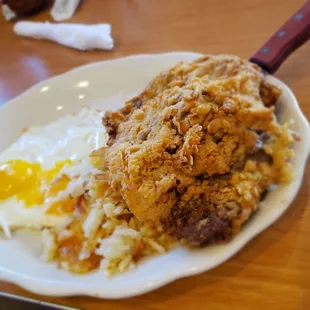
xmin=0 ymin=108 xmax=108 ymax=236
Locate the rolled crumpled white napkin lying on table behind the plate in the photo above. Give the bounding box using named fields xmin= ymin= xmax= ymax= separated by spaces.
xmin=14 ymin=21 xmax=114 ymax=51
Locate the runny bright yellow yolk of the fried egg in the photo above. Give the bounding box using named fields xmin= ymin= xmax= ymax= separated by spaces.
xmin=0 ymin=159 xmax=72 ymax=214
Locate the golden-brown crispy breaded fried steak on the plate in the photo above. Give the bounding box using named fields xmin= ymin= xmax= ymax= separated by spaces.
xmin=102 ymin=55 xmax=292 ymax=245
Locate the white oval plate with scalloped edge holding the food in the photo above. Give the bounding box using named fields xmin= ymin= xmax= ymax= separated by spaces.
xmin=0 ymin=53 xmax=310 ymax=298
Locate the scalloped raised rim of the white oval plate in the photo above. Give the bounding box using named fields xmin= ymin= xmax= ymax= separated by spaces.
xmin=0 ymin=52 xmax=310 ymax=299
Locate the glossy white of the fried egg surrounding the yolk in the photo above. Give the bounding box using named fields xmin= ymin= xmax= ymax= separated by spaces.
xmin=0 ymin=108 xmax=108 ymax=236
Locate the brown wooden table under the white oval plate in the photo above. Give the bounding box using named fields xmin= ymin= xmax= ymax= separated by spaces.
xmin=0 ymin=0 xmax=310 ymax=310
